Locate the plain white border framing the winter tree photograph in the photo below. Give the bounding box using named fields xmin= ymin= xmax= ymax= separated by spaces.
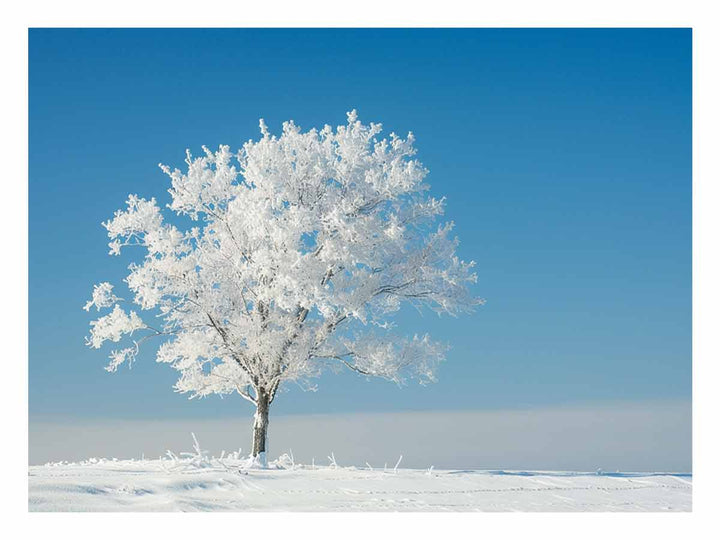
xmin=5 ymin=0 xmax=720 ymax=539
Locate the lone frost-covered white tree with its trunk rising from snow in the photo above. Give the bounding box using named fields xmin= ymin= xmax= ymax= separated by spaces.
xmin=85 ymin=111 xmax=482 ymax=456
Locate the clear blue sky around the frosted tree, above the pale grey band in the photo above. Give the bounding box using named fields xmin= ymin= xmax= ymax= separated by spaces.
xmin=29 ymin=29 xmax=692 ymax=420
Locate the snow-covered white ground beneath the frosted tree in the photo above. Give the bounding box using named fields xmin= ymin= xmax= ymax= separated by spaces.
xmin=29 ymin=452 xmax=692 ymax=512
